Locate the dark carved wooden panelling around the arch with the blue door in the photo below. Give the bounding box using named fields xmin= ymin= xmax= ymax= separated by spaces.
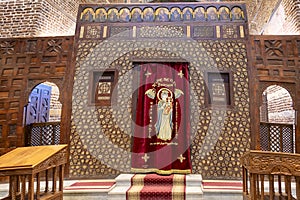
xmin=0 ymin=37 xmax=74 ymax=155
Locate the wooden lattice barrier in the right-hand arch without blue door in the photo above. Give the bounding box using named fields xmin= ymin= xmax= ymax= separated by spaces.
xmin=260 ymin=123 xmax=294 ymax=153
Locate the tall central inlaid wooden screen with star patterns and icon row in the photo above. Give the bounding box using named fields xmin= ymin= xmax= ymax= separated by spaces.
xmin=70 ymin=3 xmax=250 ymax=179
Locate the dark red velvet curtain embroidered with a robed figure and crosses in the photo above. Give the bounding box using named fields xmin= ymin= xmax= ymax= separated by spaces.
xmin=132 ymin=63 xmax=191 ymax=174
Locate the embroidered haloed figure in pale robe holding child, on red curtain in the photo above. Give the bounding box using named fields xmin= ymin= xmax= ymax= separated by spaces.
xmin=145 ymin=88 xmax=183 ymax=141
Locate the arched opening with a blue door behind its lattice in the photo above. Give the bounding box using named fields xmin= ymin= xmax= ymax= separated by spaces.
xmin=23 ymin=82 xmax=62 ymax=146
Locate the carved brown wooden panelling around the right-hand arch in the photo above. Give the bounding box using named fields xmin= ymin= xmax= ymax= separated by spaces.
xmin=249 ymin=36 xmax=300 ymax=152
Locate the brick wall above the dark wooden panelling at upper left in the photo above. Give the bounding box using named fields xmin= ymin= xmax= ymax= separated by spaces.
xmin=0 ymin=0 xmax=79 ymax=38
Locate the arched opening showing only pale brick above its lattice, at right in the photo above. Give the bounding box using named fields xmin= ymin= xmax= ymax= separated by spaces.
xmin=260 ymin=85 xmax=295 ymax=153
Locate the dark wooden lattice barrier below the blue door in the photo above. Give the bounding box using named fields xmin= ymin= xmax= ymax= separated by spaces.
xmin=25 ymin=122 xmax=60 ymax=146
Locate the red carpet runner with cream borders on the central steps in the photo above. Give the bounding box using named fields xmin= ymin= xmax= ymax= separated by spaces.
xmin=126 ymin=174 xmax=185 ymax=200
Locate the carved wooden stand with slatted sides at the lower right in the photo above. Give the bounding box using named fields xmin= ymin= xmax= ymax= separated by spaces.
xmin=241 ymin=151 xmax=300 ymax=200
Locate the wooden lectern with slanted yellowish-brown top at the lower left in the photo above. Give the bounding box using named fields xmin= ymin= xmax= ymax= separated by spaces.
xmin=0 ymin=145 xmax=67 ymax=200
